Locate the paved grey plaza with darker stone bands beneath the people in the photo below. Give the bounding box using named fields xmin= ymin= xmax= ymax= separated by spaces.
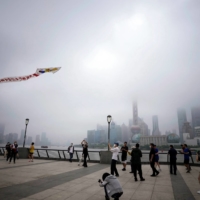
xmin=0 ymin=156 xmax=200 ymax=200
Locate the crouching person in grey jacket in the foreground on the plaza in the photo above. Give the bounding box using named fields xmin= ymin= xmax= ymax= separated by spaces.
xmin=98 ymin=173 xmax=123 ymax=200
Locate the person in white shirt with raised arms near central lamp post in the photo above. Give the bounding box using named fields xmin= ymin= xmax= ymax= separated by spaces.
xmin=108 ymin=142 xmax=120 ymax=177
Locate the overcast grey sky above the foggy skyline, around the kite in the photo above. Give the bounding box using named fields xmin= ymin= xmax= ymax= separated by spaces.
xmin=0 ymin=0 xmax=200 ymax=143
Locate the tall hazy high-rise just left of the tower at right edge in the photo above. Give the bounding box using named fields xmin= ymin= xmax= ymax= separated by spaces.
xmin=177 ymin=108 xmax=187 ymax=143
